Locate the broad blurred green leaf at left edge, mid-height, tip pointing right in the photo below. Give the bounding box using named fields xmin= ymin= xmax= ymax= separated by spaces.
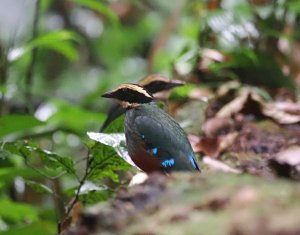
xmin=0 ymin=114 xmax=44 ymax=137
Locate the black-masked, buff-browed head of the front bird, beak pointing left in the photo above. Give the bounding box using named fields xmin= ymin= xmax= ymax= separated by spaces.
xmin=102 ymin=83 xmax=153 ymax=108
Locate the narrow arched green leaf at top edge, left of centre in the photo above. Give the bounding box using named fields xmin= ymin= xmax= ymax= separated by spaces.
xmin=72 ymin=0 xmax=119 ymax=26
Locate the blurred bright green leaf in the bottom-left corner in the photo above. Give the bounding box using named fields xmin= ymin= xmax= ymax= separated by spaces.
xmin=0 ymin=198 xmax=39 ymax=222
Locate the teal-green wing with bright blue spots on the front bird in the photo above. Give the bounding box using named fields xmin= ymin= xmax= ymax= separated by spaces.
xmin=134 ymin=116 xmax=199 ymax=171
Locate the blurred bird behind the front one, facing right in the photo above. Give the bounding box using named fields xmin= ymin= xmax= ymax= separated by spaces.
xmin=100 ymin=74 xmax=185 ymax=132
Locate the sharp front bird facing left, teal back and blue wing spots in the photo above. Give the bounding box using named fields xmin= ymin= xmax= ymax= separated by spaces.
xmin=102 ymin=83 xmax=200 ymax=174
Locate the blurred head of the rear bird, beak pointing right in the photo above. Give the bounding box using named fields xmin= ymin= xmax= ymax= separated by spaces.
xmin=139 ymin=74 xmax=185 ymax=94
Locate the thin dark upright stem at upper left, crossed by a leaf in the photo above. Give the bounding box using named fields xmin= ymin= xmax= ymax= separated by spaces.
xmin=25 ymin=0 xmax=40 ymax=113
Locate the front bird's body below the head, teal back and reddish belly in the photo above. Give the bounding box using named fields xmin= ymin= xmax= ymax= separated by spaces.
xmin=125 ymin=103 xmax=199 ymax=172
